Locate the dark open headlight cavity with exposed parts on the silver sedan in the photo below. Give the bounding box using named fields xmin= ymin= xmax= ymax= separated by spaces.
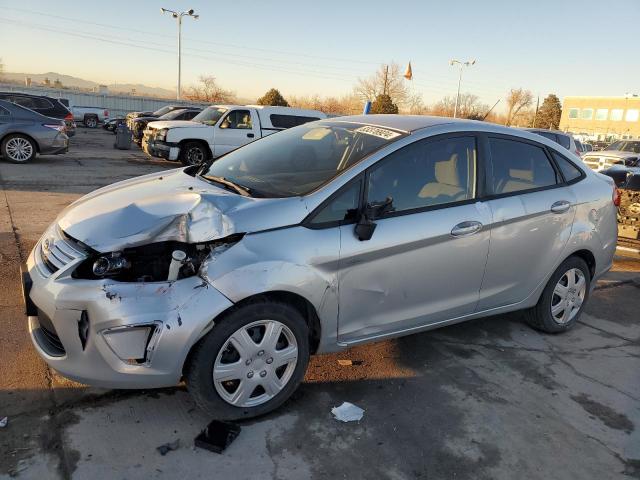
xmin=73 ymin=234 xmax=242 ymax=282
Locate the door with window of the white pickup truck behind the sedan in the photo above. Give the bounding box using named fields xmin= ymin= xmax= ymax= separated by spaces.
xmin=212 ymin=109 xmax=260 ymax=157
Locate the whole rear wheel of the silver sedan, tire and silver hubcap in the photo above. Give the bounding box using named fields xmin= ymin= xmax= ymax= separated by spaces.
xmin=526 ymin=257 xmax=591 ymax=333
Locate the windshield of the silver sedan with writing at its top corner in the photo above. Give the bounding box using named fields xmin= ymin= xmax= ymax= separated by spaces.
xmin=202 ymin=121 xmax=404 ymax=197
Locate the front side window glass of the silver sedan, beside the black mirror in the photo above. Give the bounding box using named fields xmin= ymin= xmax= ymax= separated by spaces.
xmin=368 ymin=137 xmax=476 ymax=212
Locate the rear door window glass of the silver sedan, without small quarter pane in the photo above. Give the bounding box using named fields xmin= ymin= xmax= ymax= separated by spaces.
xmin=489 ymin=138 xmax=558 ymax=194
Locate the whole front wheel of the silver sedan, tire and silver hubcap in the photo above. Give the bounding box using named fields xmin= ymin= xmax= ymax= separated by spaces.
xmin=185 ymin=300 xmax=309 ymax=420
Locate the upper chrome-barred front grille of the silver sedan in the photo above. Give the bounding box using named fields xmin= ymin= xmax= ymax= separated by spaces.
xmin=36 ymin=225 xmax=87 ymax=277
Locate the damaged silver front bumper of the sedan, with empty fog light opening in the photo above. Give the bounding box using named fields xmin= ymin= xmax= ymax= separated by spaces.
xmin=23 ymin=238 xmax=232 ymax=388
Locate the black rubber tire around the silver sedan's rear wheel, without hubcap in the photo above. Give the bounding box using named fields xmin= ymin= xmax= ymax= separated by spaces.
xmin=525 ymin=257 xmax=591 ymax=333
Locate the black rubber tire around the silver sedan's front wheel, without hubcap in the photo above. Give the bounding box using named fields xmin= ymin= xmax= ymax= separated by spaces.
xmin=185 ymin=300 xmax=309 ymax=420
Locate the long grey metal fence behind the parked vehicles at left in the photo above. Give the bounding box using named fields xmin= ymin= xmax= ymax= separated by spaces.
xmin=0 ymin=83 xmax=201 ymax=118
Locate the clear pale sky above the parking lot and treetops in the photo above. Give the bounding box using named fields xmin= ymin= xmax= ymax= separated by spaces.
xmin=0 ymin=0 xmax=640 ymax=104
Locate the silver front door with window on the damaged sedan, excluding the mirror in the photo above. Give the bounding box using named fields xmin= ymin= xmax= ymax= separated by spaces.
xmin=338 ymin=135 xmax=491 ymax=343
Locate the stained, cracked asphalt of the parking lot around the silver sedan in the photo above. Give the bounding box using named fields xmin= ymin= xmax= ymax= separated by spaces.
xmin=0 ymin=129 xmax=640 ymax=480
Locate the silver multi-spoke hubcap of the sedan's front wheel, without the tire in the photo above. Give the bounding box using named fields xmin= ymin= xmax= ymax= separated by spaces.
xmin=213 ymin=320 xmax=298 ymax=408
